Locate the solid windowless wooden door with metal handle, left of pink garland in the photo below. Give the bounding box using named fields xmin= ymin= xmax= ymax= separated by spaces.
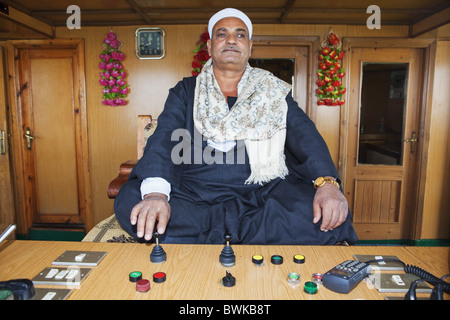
xmin=8 ymin=40 xmax=92 ymax=233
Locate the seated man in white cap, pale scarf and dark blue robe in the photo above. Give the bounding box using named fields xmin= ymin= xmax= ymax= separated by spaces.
xmin=114 ymin=8 xmax=357 ymax=245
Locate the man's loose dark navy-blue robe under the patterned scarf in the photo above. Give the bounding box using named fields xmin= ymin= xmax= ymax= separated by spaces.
xmin=114 ymin=77 xmax=357 ymax=245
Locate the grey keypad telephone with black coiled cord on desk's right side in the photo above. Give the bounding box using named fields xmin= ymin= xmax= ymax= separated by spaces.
xmin=322 ymin=259 xmax=450 ymax=300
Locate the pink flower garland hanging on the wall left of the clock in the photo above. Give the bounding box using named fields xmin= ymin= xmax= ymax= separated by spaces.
xmin=99 ymin=31 xmax=129 ymax=107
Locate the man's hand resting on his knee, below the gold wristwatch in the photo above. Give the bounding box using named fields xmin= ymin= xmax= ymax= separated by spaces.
xmin=313 ymin=183 xmax=348 ymax=232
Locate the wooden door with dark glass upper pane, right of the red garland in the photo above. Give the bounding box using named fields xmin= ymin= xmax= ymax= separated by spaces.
xmin=344 ymin=48 xmax=423 ymax=240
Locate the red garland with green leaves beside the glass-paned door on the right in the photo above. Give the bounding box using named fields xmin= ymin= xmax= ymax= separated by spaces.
xmin=316 ymin=30 xmax=346 ymax=106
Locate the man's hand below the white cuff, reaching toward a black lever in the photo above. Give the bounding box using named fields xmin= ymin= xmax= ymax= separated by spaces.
xmin=130 ymin=192 xmax=170 ymax=240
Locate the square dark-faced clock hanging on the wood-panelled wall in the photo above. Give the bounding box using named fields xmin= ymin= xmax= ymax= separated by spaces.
xmin=136 ymin=28 xmax=165 ymax=59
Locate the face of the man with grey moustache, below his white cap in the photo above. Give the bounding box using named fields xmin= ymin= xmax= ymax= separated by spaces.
xmin=207 ymin=18 xmax=253 ymax=70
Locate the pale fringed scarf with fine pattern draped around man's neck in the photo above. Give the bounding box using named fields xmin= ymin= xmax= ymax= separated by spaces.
xmin=194 ymin=59 xmax=291 ymax=185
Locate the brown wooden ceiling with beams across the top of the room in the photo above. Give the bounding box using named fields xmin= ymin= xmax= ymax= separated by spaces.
xmin=0 ymin=0 xmax=450 ymax=39
